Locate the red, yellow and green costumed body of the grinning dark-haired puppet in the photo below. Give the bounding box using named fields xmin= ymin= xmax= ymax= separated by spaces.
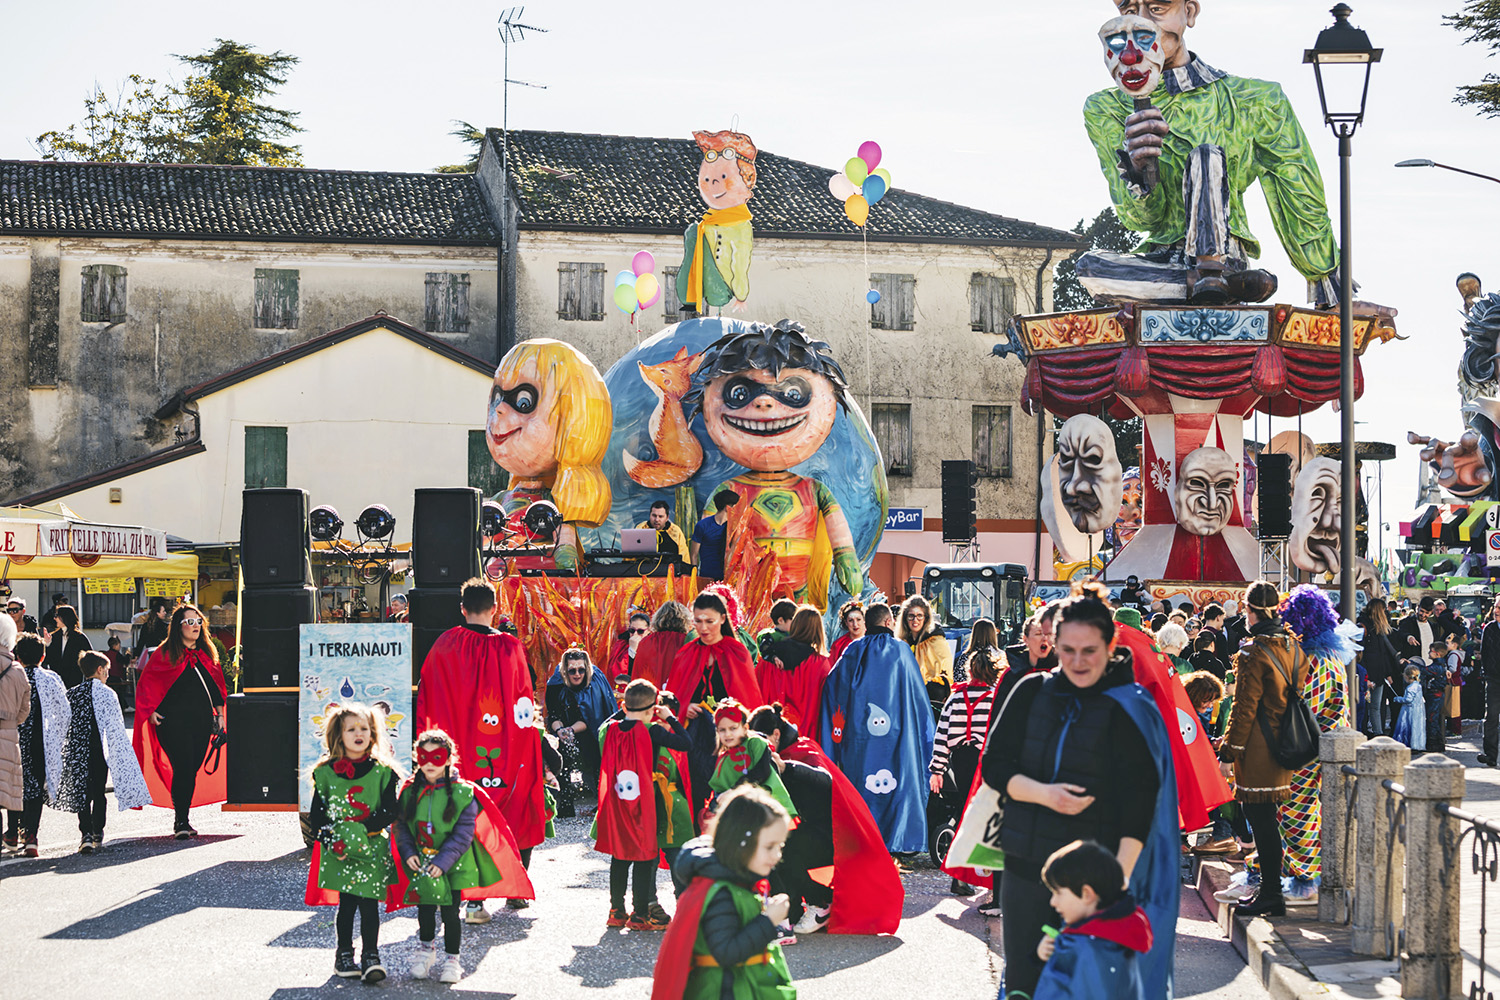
xmin=704 ymin=472 xmax=863 ymax=607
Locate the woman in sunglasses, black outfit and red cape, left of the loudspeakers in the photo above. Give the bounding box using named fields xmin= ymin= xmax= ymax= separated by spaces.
xmin=135 ymin=604 xmax=227 ymax=840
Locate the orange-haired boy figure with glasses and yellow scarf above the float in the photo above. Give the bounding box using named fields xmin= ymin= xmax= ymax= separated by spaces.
xmin=677 ymin=132 xmax=756 ymax=312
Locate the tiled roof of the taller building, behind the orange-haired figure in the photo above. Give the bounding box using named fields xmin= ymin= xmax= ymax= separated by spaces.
xmin=498 ymin=129 xmax=1079 ymax=247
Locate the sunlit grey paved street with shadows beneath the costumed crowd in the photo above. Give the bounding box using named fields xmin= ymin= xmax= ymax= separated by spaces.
xmin=0 ymin=808 xmax=1266 ymax=1000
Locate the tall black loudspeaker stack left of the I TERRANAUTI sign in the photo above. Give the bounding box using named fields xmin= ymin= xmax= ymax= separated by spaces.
xmin=225 ymin=489 xmax=318 ymax=805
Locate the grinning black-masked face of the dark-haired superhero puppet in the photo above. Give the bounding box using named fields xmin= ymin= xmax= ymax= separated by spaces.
xmin=704 ymin=367 xmax=839 ymax=472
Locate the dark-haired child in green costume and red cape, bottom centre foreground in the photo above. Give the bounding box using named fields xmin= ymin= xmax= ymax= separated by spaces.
xmin=651 ymin=786 xmax=797 ymax=1000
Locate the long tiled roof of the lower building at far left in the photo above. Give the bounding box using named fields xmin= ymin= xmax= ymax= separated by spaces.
xmin=0 ymin=160 xmax=500 ymax=246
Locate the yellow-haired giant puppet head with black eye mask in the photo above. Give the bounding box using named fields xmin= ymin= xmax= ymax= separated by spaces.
xmin=485 ymin=340 xmax=614 ymax=528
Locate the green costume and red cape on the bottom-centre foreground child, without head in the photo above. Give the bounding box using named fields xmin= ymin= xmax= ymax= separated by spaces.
xmin=651 ymin=844 xmax=797 ymax=1000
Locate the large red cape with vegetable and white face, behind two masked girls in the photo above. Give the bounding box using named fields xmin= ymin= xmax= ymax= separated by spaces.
xmin=416 ymin=625 xmax=546 ymax=849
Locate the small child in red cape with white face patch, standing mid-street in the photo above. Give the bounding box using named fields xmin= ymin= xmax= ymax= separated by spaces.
xmin=594 ymin=679 xmax=687 ymax=931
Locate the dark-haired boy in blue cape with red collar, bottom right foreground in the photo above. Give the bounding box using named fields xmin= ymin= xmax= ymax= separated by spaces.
xmin=1035 ymin=840 xmax=1152 ymax=1000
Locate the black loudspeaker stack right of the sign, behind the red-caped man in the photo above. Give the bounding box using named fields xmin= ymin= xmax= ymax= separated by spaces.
xmin=407 ymin=489 xmax=480 ymax=684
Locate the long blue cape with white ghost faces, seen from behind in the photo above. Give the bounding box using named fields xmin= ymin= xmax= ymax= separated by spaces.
xmin=822 ymin=633 xmax=936 ymax=853
